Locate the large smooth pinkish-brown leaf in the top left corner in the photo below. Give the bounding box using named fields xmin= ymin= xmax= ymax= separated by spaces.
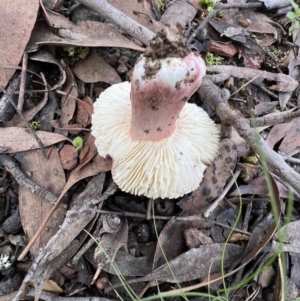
xmin=0 ymin=0 xmax=39 ymax=87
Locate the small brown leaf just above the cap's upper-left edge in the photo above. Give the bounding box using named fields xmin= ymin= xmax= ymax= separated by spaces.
xmin=71 ymin=49 xmax=122 ymax=85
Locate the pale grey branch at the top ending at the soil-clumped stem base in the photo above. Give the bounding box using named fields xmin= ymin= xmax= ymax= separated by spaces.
xmin=78 ymin=0 xmax=155 ymax=45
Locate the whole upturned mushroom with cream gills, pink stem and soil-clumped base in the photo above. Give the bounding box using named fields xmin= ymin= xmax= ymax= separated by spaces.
xmin=92 ymin=22 xmax=219 ymax=198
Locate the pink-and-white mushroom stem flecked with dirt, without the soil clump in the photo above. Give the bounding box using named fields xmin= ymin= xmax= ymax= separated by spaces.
xmin=130 ymin=53 xmax=206 ymax=142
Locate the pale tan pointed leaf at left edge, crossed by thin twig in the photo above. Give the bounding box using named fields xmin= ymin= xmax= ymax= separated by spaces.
xmin=0 ymin=127 xmax=70 ymax=154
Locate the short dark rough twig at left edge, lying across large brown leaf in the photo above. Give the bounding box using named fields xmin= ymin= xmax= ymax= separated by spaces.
xmin=0 ymin=154 xmax=57 ymax=204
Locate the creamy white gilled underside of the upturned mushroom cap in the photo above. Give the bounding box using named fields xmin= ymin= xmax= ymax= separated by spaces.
xmin=92 ymin=82 xmax=219 ymax=198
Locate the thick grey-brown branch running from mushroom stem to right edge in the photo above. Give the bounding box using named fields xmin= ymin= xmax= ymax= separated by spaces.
xmin=198 ymin=77 xmax=300 ymax=193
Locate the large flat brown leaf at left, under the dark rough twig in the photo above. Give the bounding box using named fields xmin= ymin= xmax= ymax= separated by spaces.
xmin=17 ymin=148 xmax=66 ymax=257
